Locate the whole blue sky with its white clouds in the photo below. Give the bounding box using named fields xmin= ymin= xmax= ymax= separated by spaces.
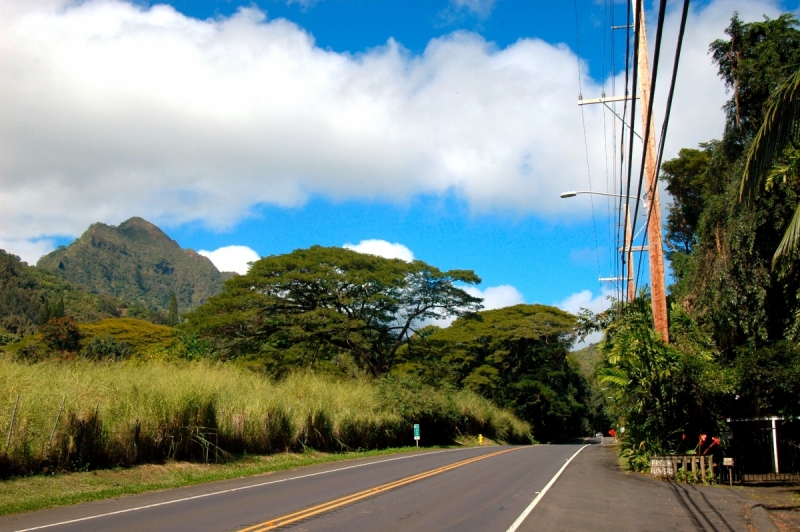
xmin=0 ymin=0 xmax=798 ymax=334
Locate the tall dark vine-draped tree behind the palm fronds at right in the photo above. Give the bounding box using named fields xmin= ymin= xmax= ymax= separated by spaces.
xmin=663 ymin=11 xmax=800 ymax=354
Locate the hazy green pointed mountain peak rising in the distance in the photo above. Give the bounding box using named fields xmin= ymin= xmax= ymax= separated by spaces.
xmin=36 ymin=218 xmax=227 ymax=312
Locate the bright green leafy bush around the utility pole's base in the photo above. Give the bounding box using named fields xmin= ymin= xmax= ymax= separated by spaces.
xmin=582 ymin=294 xmax=735 ymax=468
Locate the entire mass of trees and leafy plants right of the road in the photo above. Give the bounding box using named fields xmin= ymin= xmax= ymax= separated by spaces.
xmin=580 ymin=14 xmax=800 ymax=469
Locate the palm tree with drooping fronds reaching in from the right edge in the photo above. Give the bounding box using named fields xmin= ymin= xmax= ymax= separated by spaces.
xmin=739 ymin=70 xmax=800 ymax=265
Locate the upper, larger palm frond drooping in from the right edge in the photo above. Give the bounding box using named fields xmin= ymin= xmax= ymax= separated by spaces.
xmin=739 ymin=70 xmax=800 ymax=202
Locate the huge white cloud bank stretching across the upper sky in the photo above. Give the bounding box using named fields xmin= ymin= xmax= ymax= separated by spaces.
xmin=0 ymin=0 xmax=780 ymax=256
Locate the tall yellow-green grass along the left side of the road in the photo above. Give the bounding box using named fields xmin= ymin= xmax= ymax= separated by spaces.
xmin=0 ymin=359 xmax=531 ymax=477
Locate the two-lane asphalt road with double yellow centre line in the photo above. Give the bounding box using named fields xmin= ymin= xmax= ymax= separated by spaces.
xmin=0 ymin=445 xmax=582 ymax=532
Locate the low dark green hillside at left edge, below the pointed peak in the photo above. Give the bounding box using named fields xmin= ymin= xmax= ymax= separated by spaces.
xmin=0 ymin=249 xmax=119 ymax=336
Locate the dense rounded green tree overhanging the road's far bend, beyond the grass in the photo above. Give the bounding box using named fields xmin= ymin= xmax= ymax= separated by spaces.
xmin=397 ymin=305 xmax=588 ymax=440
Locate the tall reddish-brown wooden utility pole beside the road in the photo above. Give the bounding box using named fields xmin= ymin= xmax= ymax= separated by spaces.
xmin=631 ymin=0 xmax=669 ymax=342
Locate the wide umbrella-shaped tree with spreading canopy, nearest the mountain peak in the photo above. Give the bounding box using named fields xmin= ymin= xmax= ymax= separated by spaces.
xmin=185 ymin=246 xmax=481 ymax=376
